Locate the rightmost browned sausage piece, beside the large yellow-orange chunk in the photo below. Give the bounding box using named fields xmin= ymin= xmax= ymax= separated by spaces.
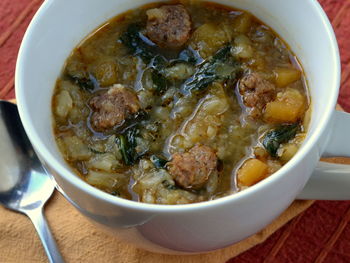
xmin=239 ymin=73 xmax=276 ymax=118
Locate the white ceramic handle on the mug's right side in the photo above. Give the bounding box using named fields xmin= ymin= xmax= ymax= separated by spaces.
xmin=297 ymin=111 xmax=350 ymax=200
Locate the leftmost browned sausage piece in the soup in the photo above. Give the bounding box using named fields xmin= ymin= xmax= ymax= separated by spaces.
xmin=89 ymin=84 xmax=140 ymax=131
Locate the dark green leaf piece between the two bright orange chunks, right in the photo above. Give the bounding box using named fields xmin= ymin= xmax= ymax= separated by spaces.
xmin=263 ymin=123 xmax=299 ymax=157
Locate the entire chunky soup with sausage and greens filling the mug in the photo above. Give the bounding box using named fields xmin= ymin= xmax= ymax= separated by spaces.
xmin=52 ymin=1 xmax=309 ymax=204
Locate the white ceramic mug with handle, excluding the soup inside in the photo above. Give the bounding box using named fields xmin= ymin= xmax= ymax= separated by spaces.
xmin=16 ymin=0 xmax=350 ymax=253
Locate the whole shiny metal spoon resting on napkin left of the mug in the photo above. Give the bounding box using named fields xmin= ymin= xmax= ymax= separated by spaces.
xmin=0 ymin=100 xmax=64 ymax=263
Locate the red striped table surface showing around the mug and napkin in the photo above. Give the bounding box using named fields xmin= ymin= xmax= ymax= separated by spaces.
xmin=0 ymin=0 xmax=350 ymax=263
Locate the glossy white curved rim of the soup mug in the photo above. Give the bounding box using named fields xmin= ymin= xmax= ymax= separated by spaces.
xmin=15 ymin=0 xmax=340 ymax=213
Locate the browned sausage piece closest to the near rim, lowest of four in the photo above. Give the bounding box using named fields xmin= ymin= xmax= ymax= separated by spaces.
xmin=168 ymin=145 xmax=217 ymax=189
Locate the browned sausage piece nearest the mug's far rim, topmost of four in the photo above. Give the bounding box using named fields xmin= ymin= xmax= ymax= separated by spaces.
xmin=146 ymin=5 xmax=191 ymax=48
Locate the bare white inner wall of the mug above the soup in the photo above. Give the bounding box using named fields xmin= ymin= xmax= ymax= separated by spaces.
xmin=16 ymin=0 xmax=339 ymax=206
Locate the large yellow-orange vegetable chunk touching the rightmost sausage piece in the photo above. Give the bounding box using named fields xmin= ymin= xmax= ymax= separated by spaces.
xmin=263 ymin=89 xmax=306 ymax=123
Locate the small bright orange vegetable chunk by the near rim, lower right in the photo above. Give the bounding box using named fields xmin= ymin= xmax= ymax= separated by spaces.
xmin=237 ymin=159 xmax=268 ymax=186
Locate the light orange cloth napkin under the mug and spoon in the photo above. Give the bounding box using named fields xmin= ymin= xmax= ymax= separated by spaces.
xmin=0 ymin=103 xmax=350 ymax=263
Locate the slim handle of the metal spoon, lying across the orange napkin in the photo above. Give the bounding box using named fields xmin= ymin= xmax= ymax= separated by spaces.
xmin=25 ymin=207 xmax=64 ymax=263
